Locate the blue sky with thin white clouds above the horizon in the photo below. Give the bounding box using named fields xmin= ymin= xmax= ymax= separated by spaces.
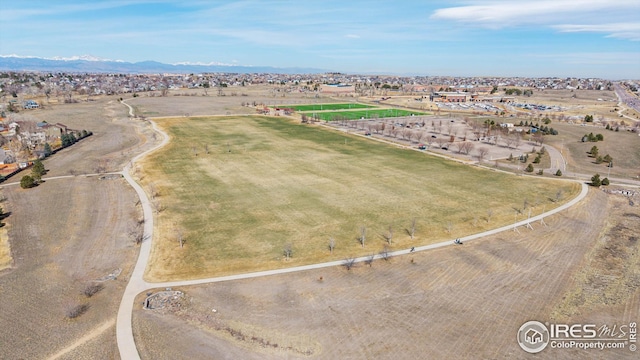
xmin=0 ymin=0 xmax=640 ymax=79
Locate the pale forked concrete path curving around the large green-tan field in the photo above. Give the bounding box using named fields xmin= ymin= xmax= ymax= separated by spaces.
xmin=116 ymin=107 xmax=588 ymax=360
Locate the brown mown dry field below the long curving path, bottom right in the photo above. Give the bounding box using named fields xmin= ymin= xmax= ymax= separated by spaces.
xmin=134 ymin=190 xmax=640 ymax=359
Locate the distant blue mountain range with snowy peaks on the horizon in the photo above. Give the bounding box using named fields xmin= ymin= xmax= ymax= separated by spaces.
xmin=0 ymin=55 xmax=327 ymax=74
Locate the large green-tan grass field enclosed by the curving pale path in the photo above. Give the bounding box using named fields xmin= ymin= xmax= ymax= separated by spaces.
xmin=141 ymin=116 xmax=579 ymax=280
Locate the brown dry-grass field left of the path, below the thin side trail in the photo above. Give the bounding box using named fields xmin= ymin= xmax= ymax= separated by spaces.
xmin=0 ymin=176 xmax=137 ymax=359
